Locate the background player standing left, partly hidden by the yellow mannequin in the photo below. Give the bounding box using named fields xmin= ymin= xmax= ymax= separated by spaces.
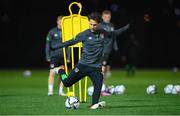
xmin=46 ymin=16 xmax=65 ymax=96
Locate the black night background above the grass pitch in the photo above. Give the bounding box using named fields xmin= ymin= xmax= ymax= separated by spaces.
xmin=0 ymin=0 xmax=180 ymax=68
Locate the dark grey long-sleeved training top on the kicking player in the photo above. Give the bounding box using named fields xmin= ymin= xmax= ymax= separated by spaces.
xmin=58 ymin=24 xmax=129 ymax=68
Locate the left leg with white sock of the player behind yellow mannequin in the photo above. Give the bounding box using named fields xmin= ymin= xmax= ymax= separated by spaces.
xmin=48 ymin=69 xmax=54 ymax=96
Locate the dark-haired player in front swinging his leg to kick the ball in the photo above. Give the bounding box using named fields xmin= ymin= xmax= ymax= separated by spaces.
xmin=54 ymin=13 xmax=129 ymax=109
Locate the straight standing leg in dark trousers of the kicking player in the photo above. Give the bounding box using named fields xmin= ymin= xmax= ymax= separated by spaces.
xmin=88 ymin=70 xmax=103 ymax=106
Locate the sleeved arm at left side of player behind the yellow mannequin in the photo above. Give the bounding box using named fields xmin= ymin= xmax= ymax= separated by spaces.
xmin=45 ymin=32 xmax=52 ymax=62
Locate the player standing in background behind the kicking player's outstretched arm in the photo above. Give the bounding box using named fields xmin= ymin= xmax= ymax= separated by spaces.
xmin=100 ymin=10 xmax=118 ymax=96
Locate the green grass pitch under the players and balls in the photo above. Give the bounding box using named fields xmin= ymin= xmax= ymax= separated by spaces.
xmin=0 ymin=70 xmax=180 ymax=115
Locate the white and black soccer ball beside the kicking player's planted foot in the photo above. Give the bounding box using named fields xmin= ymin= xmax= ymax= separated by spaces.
xmin=65 ymin=97 xmax=79 ymax=109
